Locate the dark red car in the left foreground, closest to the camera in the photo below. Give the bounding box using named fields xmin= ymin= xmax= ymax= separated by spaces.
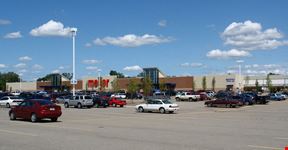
xmin=9 ymin=99 xmax=62 ymax=122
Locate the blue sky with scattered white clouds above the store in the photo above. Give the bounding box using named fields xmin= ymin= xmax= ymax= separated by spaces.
xmin=0 ymin=0 xmax=288 ymax=81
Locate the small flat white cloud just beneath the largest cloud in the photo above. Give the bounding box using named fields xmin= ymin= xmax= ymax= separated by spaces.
xmin=206 ymin=49 xmax=250 ymax=59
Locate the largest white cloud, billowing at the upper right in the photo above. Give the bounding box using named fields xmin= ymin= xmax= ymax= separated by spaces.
xmin=222 ymin=20 xmax=288 ymax=50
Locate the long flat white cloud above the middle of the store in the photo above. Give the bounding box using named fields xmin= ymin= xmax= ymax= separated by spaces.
xmin=94 ymin=34 xmax=172 ymax=47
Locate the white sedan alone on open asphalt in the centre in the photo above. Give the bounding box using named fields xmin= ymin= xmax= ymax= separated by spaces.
xmin=135 ymin=99 xmax=179 ymax=113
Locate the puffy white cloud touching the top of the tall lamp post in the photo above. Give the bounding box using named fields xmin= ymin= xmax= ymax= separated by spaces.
xmin=30 ymin=20 xmax=72 ymax=37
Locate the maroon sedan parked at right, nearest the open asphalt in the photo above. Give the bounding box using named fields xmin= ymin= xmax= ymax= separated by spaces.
xmin=204 ymin=98 xmax=243 ymax=107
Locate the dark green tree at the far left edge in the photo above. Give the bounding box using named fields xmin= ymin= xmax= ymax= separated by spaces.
xmin=0 ymin=72 xmax=20 ymax=91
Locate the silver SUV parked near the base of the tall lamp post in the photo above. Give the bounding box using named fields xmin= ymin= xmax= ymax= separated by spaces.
xmin=64 ymin=95 xmax=93 ymax=108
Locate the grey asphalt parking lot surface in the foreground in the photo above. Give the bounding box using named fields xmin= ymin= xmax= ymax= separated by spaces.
xmin=0 ymin=101 xmax=288 ymax=150
